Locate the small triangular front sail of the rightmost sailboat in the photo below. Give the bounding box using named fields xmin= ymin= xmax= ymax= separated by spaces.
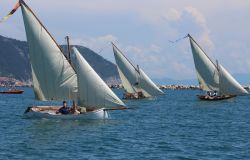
xmin=218 ymin=64 xmax=248 ymax=95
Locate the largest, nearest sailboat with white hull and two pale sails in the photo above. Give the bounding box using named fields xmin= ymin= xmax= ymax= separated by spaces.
xmin=12 ymin=0 xmax=125 ymax=119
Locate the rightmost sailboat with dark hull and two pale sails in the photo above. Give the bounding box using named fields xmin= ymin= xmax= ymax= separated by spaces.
xmin=187 ymin=34 xmax=248 ymax=100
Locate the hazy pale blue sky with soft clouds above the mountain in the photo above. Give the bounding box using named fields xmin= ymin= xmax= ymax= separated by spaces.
xmin=0 ymin=0 xmax=250 ymax=79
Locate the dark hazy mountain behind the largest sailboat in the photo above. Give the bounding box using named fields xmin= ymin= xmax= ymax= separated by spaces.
xmin=0 ymin=35 xmax=119 ymax=81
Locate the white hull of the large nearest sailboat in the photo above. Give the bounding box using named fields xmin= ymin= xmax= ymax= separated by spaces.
xmin=24 ymin=106 xmax=109 ymax=120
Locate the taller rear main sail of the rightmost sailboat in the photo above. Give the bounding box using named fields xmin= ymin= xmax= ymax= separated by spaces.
xmin=189 ymin=35 xmax=219 ymax=91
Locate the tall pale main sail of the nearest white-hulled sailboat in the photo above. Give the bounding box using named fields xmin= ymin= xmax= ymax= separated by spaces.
xmin=20 ymin=1 xmax=77 ymax=100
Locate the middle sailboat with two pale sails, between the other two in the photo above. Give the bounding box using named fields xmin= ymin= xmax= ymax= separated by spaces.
xmin=112 ymin=43 xmax=164 ymax=99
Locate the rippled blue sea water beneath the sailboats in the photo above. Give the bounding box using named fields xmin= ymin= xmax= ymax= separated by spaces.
xmin=0 ymin=88 xmax=250 ymax=160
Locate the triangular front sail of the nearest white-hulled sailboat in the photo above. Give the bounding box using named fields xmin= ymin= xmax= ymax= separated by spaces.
xmin=73 ymin=47 xmax=125 ymax=108
